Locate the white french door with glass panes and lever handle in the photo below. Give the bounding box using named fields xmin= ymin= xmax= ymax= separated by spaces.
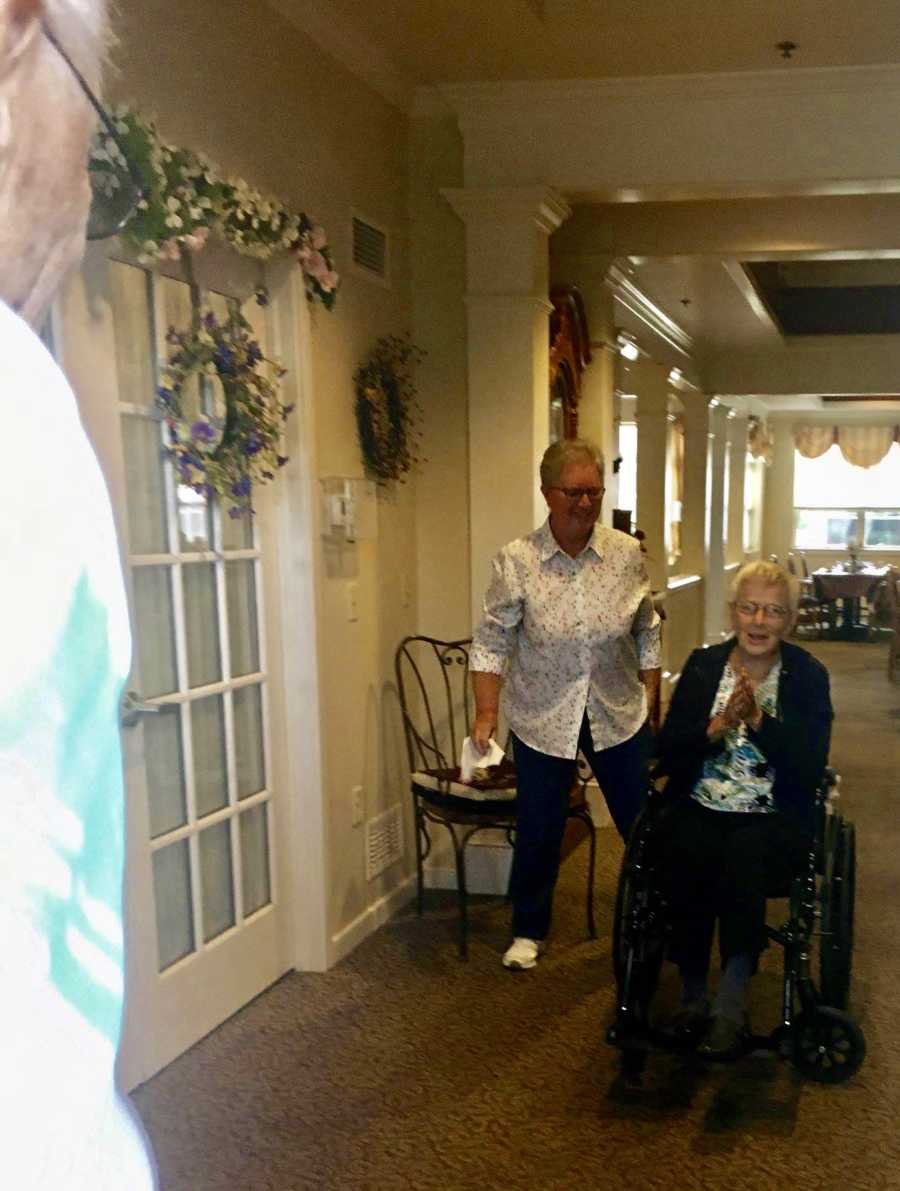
xmin=60 ymin=251 xmax=290 ymax=1087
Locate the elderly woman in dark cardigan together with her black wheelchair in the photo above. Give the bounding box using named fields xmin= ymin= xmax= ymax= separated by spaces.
xmin=610 ymin=561 xmax=864 ymax=1079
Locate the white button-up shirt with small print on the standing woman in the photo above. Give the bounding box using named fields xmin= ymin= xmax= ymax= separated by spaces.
xmin=470 ymin=518 xmax=660 ymax=757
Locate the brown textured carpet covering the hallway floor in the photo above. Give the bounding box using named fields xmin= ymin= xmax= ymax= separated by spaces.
xmin=133 ymin=642 xmax=900 ymax=1191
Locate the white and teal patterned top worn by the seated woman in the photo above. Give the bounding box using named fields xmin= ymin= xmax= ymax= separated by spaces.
xmin=693 ymin=660 xmax=781 ymax=815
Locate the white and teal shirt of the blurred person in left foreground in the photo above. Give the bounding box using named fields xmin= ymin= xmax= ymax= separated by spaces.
xmin=0 ymin=301 xmax=155 ymax=1191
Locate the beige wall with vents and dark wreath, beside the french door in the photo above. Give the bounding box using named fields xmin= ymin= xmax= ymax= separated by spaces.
xmin=108 ymin=0 xmax=417 ymax=939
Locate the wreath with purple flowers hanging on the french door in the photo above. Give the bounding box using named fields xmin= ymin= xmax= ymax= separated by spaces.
xmin=157 ymin=302 xmax=294 ymax=517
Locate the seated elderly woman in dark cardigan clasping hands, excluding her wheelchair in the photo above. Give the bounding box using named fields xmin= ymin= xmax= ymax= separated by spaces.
xmin=657 ymin=561 xmax=832 ymax=1060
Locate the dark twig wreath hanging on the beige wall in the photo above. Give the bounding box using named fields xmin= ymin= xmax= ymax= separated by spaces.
xmin=354 ymin=335 xmax=425 ymax=484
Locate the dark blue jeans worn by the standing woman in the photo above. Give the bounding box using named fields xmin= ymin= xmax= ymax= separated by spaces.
xmin=510 ymin=716 xmax=652 ymax=939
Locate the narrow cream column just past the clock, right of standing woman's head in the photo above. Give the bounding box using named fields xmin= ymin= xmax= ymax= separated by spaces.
xmin=626 ymin=356 xmax=669 ymax=591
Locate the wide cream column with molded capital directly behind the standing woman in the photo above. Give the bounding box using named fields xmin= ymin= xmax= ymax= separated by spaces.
xmin=443 ymin=187 xmax=569 ymax=623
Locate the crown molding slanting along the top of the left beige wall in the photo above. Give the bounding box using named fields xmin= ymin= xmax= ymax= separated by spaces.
xmin=267 ymin=0 xmax=415 ymax=112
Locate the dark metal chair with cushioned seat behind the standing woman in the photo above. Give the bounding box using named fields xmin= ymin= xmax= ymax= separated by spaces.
xmin=394 ymin=636 xmax=596 ymax=959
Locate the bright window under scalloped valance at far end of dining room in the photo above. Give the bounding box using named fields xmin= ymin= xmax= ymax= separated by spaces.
xmin=794 ymin=443 xmax=900 ymax=554
